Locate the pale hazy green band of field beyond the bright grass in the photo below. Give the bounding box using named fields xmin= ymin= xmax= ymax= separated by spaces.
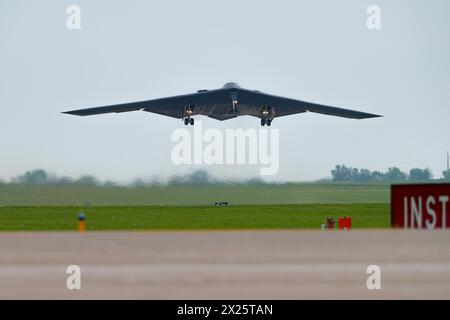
xmin=0 ymin=183 xmax=390 ymax=206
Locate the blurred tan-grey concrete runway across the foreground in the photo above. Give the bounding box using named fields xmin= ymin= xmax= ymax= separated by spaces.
xmin=0 ymin=230 xmax=450 ymax=299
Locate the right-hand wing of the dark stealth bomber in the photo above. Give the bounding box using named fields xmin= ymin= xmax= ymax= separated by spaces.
xmin=239 ymin=90 xmax=381 ymax=119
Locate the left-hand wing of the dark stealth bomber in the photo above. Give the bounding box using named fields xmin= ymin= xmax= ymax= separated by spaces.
xmin=64 ymin=89 xmax=230 ymax=119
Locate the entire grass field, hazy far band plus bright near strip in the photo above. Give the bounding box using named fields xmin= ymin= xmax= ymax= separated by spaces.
xmin=0 ymin=183 xmax=389 ymax=231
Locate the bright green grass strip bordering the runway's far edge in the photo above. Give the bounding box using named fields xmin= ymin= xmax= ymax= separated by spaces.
xmin=0 ymin=203 xmax=390 ymax=231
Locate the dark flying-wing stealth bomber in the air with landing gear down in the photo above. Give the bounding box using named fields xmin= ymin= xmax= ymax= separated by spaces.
xmin=64 ymin=82 xmax=381 ymax=126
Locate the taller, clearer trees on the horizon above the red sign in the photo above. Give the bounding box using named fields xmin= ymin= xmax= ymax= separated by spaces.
xmin=331 ymin=165 xmax=444 ymax=182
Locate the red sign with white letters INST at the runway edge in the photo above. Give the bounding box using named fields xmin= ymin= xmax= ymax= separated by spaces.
xmin=391 ymin=184 xmax=450 ymax=229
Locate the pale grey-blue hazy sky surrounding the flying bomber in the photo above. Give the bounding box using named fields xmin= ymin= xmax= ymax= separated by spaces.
xmin=0 ymin=0 xmax=450 ymax=181
